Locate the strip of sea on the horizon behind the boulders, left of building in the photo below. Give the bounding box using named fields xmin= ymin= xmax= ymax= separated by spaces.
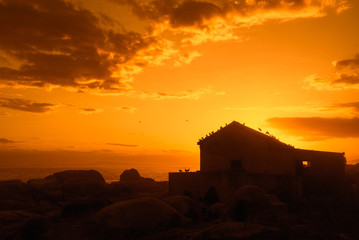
xmin=0 ymin=167 xmax=178 ymax=183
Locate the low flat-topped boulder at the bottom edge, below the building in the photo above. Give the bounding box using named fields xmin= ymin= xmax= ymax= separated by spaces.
xmin=191 ymin=222 xmax=276 ymax=240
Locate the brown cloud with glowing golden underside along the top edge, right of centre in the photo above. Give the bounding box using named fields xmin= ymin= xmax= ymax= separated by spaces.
xmin=117 ymin=0 xmax=348 ymax=45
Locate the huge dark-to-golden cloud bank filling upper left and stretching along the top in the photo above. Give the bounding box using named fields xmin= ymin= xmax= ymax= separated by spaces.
xmin=0 ymin=0 xmax=351 ymax=93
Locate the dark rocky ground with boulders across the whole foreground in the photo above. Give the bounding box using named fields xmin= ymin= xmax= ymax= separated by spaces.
xmin=0 ymin=169 xmax=359 ymax=240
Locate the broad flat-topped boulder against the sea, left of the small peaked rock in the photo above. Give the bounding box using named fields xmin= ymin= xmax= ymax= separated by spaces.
xmin=51 ymin=170 xmax=106 ymax=197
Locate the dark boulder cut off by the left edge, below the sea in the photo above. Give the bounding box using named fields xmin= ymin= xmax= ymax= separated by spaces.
xmin=0 ymin=180 xmax=33 ymax=210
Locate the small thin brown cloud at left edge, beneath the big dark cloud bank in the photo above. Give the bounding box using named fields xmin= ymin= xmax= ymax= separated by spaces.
xmin=0 ymin=98 xmax=56 ymax=113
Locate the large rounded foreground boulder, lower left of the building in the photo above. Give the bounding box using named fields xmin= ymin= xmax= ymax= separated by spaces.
xmin=94 ymin=197 xmax=184 ymax=239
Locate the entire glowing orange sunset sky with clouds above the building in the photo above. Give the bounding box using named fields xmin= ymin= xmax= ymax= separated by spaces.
xmin=0 ymin=0 xmax=359 ymax=169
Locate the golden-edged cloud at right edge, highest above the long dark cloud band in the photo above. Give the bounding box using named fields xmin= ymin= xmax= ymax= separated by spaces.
xmin=304 ymin=54 xmax=359 ymax=90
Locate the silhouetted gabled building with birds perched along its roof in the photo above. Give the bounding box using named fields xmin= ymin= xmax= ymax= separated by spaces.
xmin=169 ymin=121 xmax=346 ymax=201
